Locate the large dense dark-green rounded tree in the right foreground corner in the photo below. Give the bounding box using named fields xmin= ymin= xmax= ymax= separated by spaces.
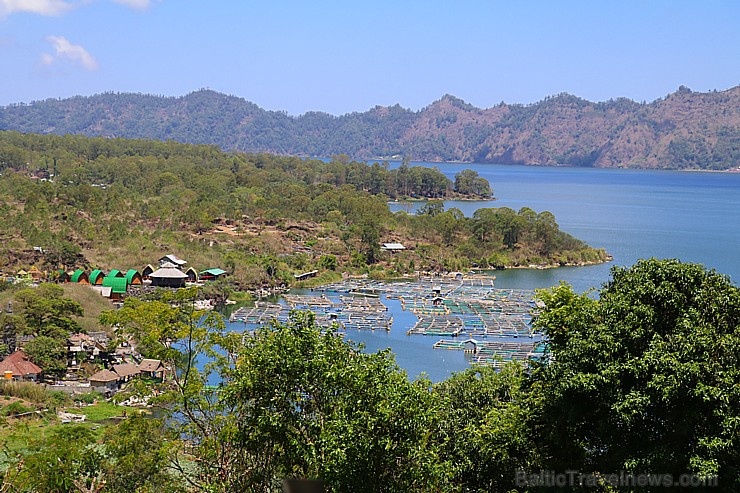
xmin=532 ymin=259 xmax=740 ymax=491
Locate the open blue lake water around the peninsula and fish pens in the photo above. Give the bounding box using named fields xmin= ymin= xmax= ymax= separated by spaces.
xmin=224 ymin=163 xmax=740 ymax=381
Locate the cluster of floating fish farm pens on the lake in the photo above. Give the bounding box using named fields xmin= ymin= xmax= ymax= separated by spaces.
xmin=230 ymin=276 xmax=544 ymax=366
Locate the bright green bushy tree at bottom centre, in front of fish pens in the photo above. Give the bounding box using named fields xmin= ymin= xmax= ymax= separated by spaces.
xmin=219 ymin=312 xmax=439 ymax=492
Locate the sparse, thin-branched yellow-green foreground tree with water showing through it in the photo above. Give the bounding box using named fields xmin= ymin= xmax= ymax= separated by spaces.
xmin=101 ymin=288 xmax=236 ymax=491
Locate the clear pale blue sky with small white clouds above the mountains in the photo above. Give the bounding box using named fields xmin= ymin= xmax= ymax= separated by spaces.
xmin=0 ymin=0 xmax=740 ymax=115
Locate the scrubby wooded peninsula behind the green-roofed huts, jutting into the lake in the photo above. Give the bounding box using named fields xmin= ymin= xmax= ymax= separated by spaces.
xmin=0 ymin=132 xmax=606 ymax=287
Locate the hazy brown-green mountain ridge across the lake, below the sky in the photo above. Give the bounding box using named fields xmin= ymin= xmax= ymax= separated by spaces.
xmin=0 ymin=86 xmax=740 ymax=169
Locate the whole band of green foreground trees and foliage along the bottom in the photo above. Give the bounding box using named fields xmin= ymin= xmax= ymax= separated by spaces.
xmin=4 ymin=260 xmax=740 ymax=493
